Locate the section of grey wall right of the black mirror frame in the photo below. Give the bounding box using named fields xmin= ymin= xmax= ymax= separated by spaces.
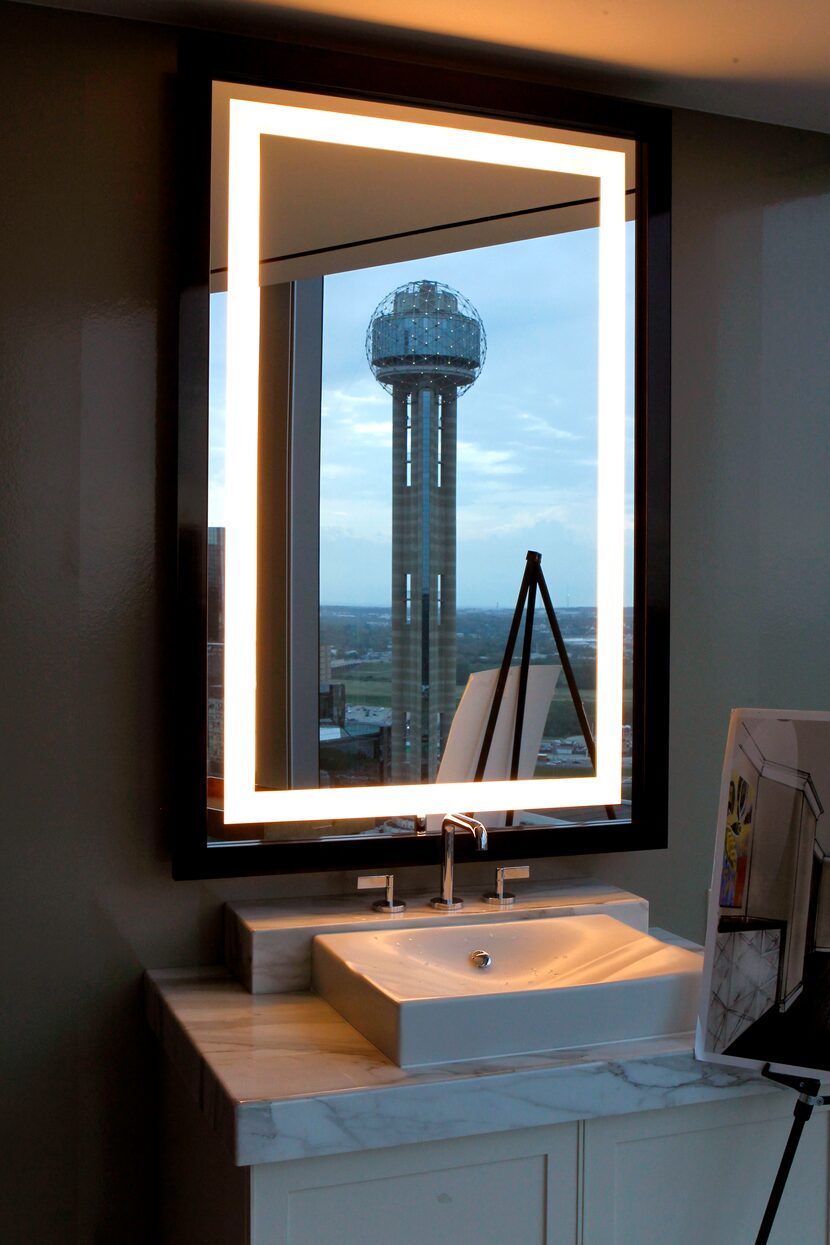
xmin=586 ymin=112 xmax=830 ymax=937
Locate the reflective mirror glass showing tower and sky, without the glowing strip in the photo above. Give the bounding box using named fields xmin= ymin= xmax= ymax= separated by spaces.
xmin=207 ymin=87 xmax=635 ymax=838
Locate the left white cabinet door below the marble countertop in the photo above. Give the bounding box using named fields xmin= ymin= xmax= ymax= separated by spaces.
xmin=251 ymin=1124 xmax=577 ymax=1245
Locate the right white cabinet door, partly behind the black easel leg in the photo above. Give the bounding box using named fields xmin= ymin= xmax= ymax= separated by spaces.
xmin=582 ymin=1093 xmax=828 ymax=1245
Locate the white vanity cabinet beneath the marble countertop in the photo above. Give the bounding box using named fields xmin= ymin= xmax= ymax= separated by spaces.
xmin=162 ymin=1060 xmax=830 ymax=1245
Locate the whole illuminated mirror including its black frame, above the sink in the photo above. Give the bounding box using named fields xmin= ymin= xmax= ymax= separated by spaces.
xmin=175 ymin=42 xmax=668 ymax=876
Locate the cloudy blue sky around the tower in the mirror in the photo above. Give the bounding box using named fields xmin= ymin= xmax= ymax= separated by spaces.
xmin=210 ymin=227 xmax=633 ymax=608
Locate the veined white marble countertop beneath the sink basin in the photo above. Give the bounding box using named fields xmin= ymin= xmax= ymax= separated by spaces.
xmin=146 ymin=946 xmax=779 ymax=1167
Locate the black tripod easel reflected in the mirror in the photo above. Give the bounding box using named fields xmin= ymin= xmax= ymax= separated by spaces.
xmin=473 ymin=549 xmax=616 ymax=825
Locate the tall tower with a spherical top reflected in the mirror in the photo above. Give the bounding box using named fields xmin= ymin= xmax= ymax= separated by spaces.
xmin=366 ymin=281 xmax=487 ymax=782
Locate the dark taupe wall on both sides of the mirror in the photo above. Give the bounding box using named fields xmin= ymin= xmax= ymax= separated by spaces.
xmin=0 ymin=5 xmax=830 ymax=1245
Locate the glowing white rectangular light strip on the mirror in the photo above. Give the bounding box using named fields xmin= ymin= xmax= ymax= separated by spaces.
xmin=224 ymin=92 xmax=626 ymax=824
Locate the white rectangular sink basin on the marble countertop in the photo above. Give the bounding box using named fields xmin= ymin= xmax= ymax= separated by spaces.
xmin=312 ymin=915 xmax=702 ymax=1068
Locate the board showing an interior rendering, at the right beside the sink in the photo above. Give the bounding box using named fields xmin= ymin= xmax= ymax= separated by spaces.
xmin=696 ymin=708 xmax=830 ymax=1079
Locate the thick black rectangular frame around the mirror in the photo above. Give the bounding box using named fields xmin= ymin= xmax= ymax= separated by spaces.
xmin=170 ymin=34 xmax=671 ymax=879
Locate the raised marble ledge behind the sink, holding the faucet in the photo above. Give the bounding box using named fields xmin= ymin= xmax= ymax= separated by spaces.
xmin=225 ymin=878 xmax=648 ymax=995
